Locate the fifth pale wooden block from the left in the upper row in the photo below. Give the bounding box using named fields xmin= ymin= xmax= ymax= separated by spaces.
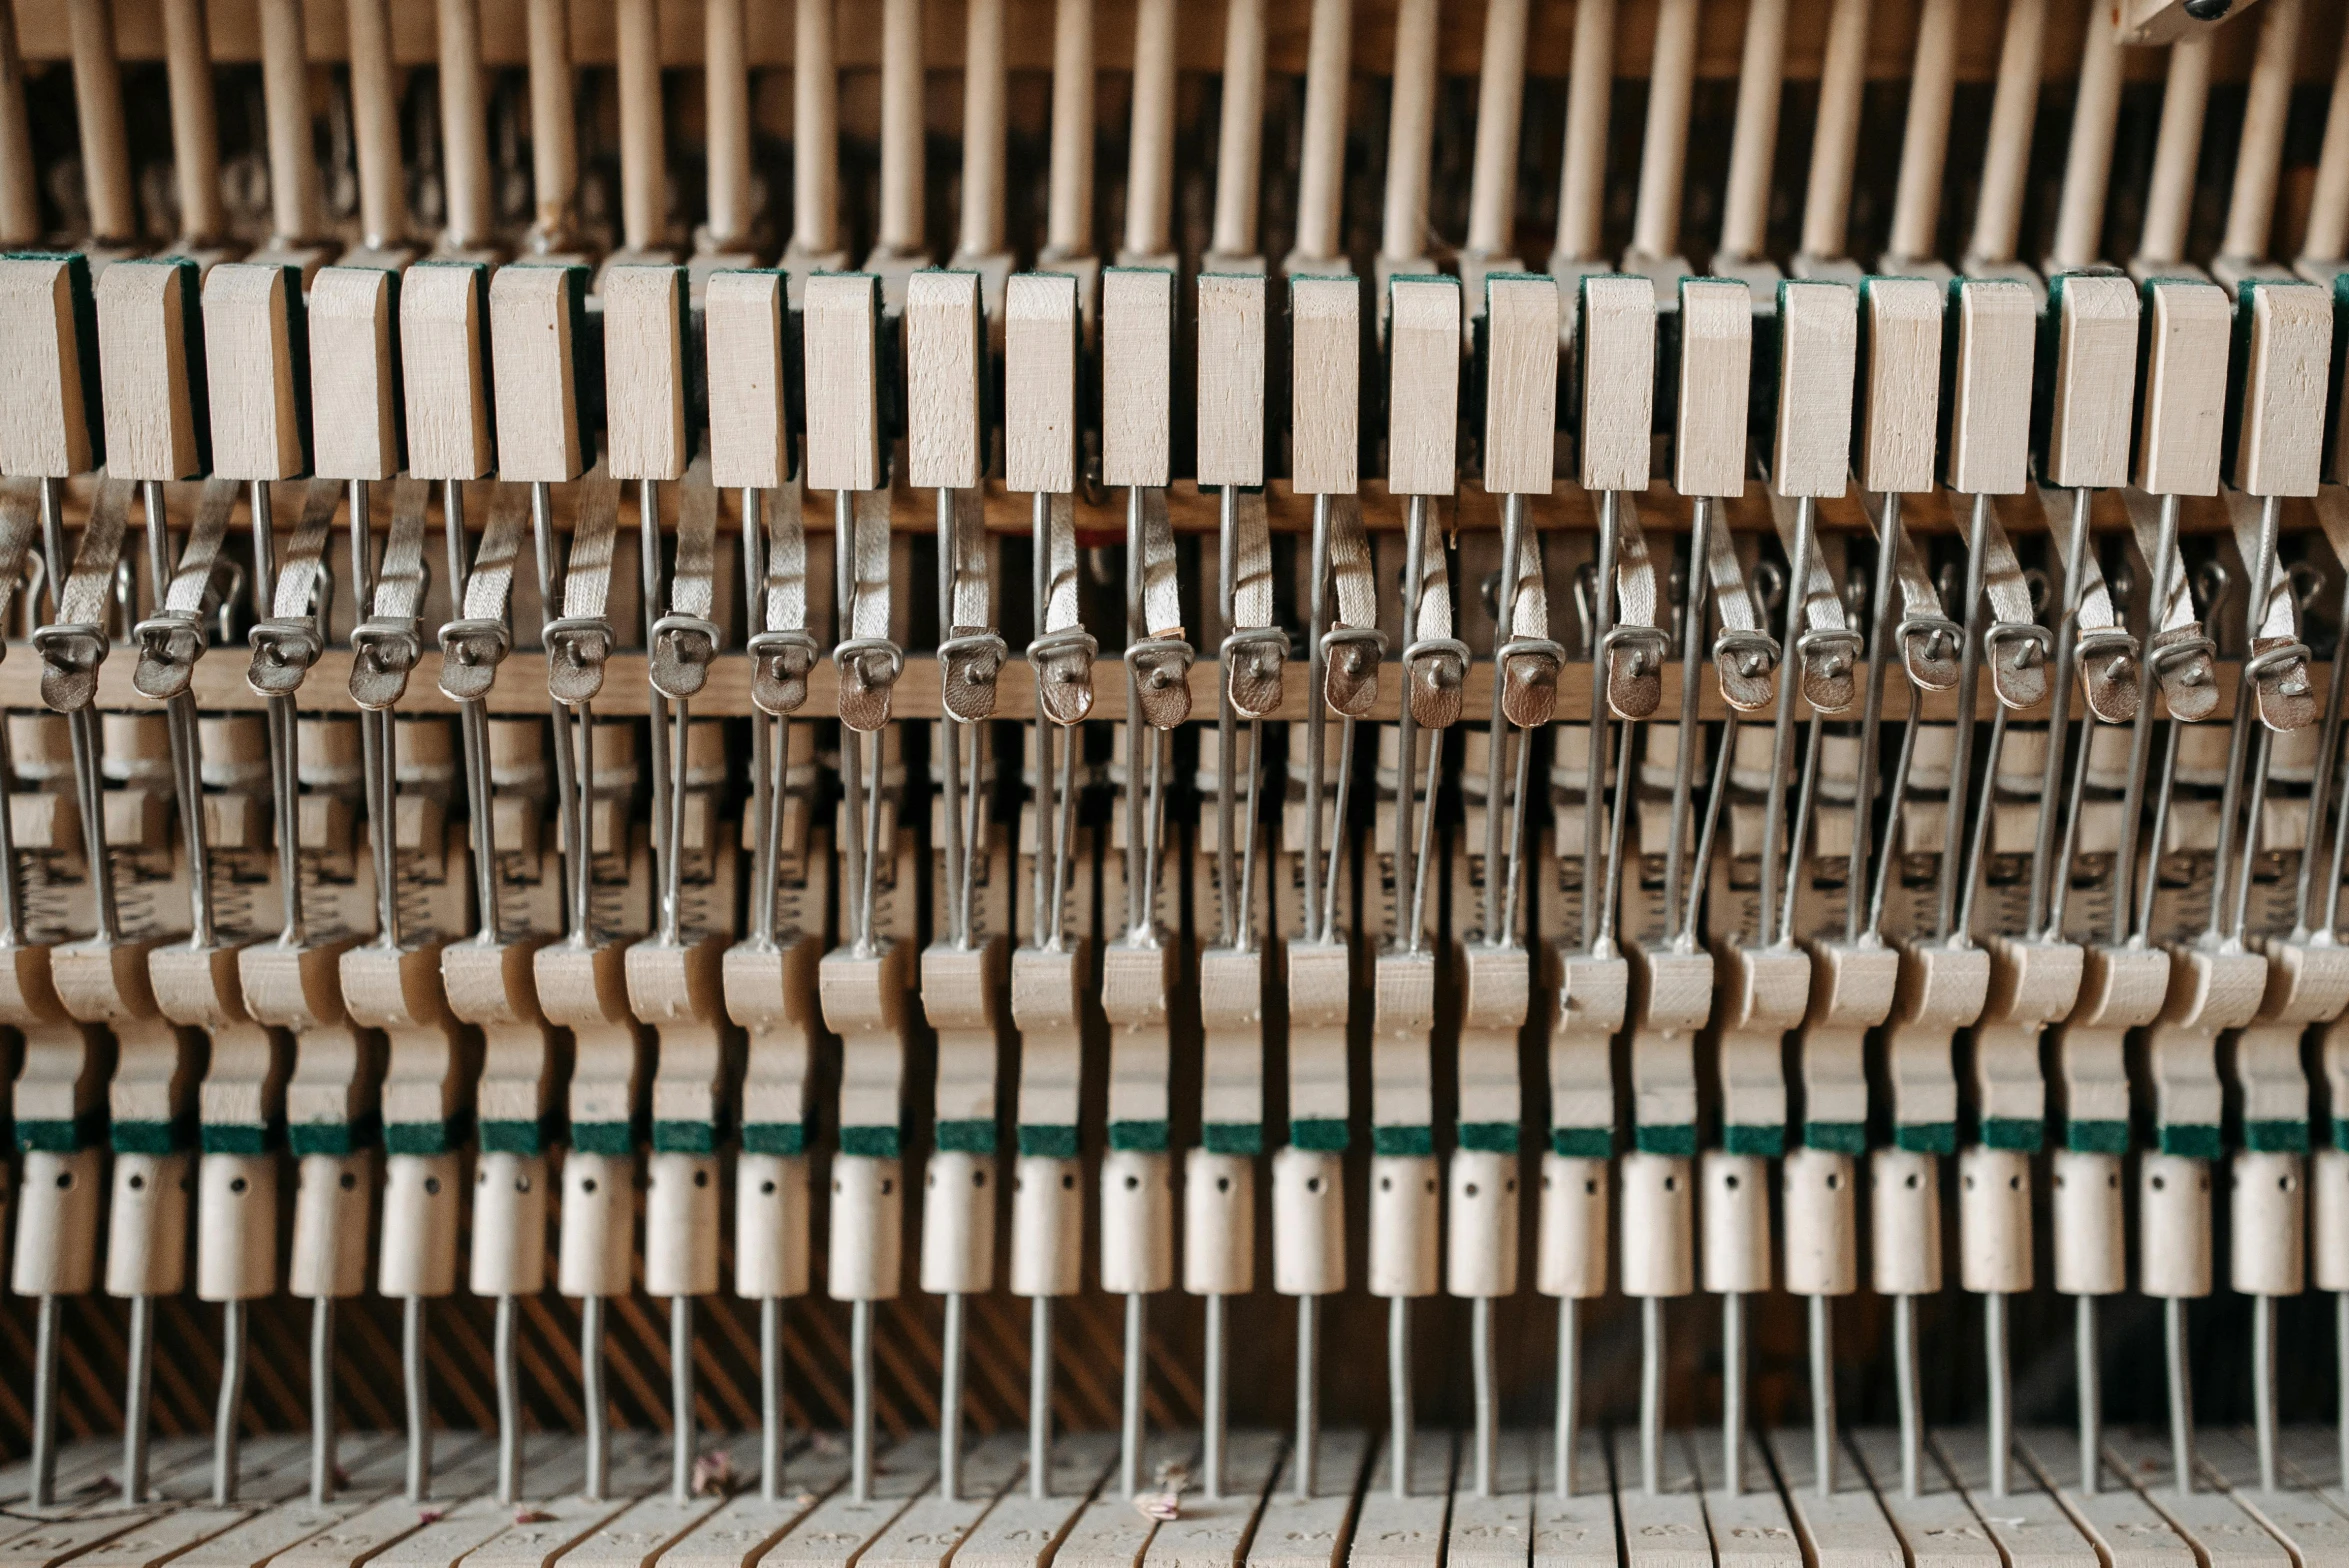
xmin=399 ymin=261 xmax=493 ymax=479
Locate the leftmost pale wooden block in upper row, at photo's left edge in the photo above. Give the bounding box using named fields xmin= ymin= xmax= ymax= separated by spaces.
xmin=0 ymin=254 xmax=106 ymax=479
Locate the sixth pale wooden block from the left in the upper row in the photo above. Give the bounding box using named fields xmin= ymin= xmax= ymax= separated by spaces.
xmin=489 ymin=265 xmax=587 ymax=484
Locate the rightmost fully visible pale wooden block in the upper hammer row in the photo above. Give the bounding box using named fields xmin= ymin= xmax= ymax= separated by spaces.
xmin=2234 ymin=282 xmax=2333 ymax=495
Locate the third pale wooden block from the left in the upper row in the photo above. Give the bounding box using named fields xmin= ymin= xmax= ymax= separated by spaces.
xmin=204 ymin=261 xmax=310 ymax=479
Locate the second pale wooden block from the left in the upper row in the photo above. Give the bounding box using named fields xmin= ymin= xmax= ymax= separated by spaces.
xmin=99 ymin=261 xmax=207 ymax=479
